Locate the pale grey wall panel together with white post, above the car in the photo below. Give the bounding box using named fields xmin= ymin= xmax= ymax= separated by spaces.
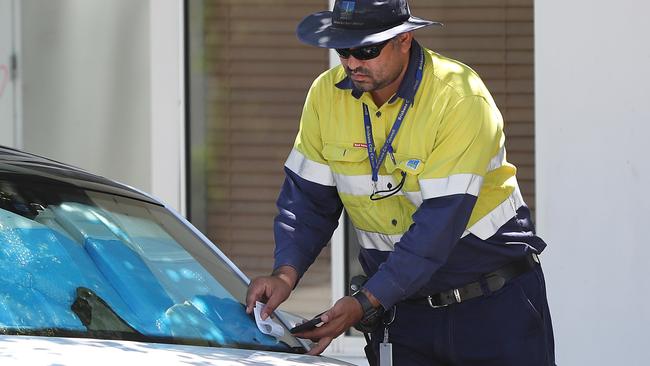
xmin=19 ymin=0 xmax=184 ymax=211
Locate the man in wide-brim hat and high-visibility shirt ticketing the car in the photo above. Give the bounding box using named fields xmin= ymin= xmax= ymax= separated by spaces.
xmin=247 ymin=0 xmax=555 ymax=366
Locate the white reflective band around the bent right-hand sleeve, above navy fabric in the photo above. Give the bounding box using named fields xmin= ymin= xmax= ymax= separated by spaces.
xmin=420 ymin=174 xmax=483 ymax=200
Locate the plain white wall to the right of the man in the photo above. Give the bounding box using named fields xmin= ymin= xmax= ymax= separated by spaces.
xmin=535 ymin=0 xmax=650 ymax=366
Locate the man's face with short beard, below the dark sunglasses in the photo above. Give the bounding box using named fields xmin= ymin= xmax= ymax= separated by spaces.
xmin=339 ymin=39 xmax=403 ymax=92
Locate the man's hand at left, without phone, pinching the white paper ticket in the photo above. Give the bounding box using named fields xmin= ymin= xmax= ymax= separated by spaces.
xmin=246 ymin=266 xmax=298 ymax=320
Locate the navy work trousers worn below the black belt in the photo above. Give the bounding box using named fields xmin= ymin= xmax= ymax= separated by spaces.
xmin=372 ymin=266 xmax=555 ymax=366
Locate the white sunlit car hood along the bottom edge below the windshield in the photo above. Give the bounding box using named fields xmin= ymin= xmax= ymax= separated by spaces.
xmin=0 ymin=336 xmax=350 ymax=366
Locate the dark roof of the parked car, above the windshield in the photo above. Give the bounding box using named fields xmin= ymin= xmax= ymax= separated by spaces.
xmin=0 ymin=145 xmax=162 ymax=206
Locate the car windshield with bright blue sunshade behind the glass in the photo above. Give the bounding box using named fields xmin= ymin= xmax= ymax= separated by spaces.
xmin=0 ymin=175 xmax=304 ymax=352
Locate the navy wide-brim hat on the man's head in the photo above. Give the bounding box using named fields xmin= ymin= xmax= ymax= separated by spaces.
xmin=296 ymin=0 xmax=442 ymax=48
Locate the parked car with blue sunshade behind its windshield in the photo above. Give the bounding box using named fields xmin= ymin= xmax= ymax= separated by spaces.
xmin=0 ymin=147 xmax=348 ymax=366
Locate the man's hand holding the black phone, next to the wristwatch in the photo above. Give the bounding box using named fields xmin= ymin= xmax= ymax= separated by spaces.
xmin=294 ymin=296 xmax=363 ymax=355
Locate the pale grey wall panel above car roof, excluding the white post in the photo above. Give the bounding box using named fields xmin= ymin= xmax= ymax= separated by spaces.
xmin=19 ymin=0 xmax=152 ymax=191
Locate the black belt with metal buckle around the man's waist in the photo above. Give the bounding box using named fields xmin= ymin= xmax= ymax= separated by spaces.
xmin=405 ymin=254 xmax=539 ymax=308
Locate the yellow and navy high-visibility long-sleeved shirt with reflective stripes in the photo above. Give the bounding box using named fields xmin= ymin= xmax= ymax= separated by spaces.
xmin=275 ymin=41 xmax=545 ymax=307
